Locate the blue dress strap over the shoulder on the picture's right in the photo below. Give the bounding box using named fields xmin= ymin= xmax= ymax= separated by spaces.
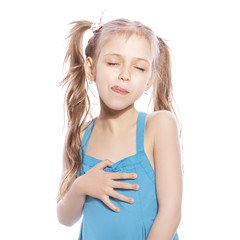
xmin=136 ymin=111 xmax=147 ymax=153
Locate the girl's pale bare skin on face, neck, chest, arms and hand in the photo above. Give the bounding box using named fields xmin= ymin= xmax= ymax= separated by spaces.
xmin=57 ymin=32 xmax=182 ymax=240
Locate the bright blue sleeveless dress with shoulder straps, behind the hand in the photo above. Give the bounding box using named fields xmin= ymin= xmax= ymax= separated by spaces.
xmin=78 ymin=111 xmax=179 ymax=240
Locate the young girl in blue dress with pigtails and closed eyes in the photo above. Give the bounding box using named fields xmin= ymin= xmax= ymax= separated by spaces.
xmin=57 ymin=19 xmax=182 ymax=240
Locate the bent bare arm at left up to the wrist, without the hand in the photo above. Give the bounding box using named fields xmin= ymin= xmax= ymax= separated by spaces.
xmin=57 ymin=135 xmax=86 ymax=226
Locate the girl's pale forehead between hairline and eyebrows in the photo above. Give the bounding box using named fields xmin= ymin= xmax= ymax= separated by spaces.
xmin=99 ymin=34 xmax=152 ymax=62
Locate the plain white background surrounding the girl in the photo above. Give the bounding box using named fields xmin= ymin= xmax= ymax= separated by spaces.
xmin=0 ymin=0 xmax=240 ymax=240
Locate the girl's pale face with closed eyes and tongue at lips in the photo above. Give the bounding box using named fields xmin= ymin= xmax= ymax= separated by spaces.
xmin=85 ymin=35 xmax=154 ymax=110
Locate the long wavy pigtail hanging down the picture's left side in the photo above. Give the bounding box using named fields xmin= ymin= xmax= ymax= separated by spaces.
xmin=58 ymin=21 xmax=92 ymax=201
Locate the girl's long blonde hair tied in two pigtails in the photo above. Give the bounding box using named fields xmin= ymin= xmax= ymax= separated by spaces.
xmin=58 ymin=19 xmax=181 ymax=201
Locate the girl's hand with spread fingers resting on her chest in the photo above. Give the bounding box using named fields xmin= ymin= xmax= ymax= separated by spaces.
xmin=82 ymin=159 xmax=139 ymax=212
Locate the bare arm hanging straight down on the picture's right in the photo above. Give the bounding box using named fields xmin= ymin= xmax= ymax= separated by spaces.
xmin=147 ymin=110 xmax=182 ymax=240
